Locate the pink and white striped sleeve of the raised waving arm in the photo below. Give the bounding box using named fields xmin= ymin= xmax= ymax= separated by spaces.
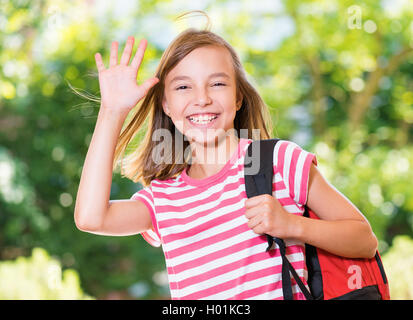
xmin=131 ymin=186 xmax=162 ymax=247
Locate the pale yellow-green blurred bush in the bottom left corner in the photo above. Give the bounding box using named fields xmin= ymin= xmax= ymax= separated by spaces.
xmin=0 ymin=248 xmax=93 ymax=300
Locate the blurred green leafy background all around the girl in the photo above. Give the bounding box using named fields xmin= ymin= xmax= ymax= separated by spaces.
xmin=0 ymin=0 xmax=413 ymax=299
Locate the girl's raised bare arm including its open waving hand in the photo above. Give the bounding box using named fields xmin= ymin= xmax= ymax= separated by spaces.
xmin=74 ymin=37 xmax=159 ymax=235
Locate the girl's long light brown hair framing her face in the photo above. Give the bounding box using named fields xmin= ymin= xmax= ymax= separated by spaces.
xmin=113 ymin=28 xmax=272 ymax=186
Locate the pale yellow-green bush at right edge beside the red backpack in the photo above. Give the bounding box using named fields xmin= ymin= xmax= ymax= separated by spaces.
xmin=382 ymin=235 xmax=413 ymax=300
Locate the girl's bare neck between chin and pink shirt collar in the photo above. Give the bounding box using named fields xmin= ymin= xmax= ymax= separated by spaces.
xmin=187 ymin=135 xmax=239 ymax=179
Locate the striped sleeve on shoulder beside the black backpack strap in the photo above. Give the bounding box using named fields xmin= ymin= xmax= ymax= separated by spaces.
xmin=274 ymin=140 xmax=317 ymax=205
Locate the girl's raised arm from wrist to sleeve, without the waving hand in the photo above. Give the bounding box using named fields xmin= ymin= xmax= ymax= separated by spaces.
xmin=74 ymin=106 xmax=152 ymax=236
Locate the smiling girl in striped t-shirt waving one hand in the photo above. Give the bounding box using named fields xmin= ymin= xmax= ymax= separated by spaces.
xmin=75 ymin=25 xmax=377 ymax=299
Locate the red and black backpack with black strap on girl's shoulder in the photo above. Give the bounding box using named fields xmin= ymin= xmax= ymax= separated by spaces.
xmin=244 ymin=139 xmax=390 ymax=300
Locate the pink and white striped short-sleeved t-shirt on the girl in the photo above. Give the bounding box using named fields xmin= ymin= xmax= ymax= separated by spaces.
xmin=131 ymin=138 xmax=317 ymax=300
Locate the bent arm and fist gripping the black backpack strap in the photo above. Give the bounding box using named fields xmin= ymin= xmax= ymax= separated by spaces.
xmin=245 ymin=164 xmax=377 ymax=258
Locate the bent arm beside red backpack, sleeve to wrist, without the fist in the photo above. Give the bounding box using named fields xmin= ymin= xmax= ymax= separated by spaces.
xmin=291 ymin=164 xmax=377 ymax=258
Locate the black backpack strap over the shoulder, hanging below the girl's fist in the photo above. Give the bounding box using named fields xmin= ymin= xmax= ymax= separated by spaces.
xmin=244 ymin=139 xmax=313 ymax=300
